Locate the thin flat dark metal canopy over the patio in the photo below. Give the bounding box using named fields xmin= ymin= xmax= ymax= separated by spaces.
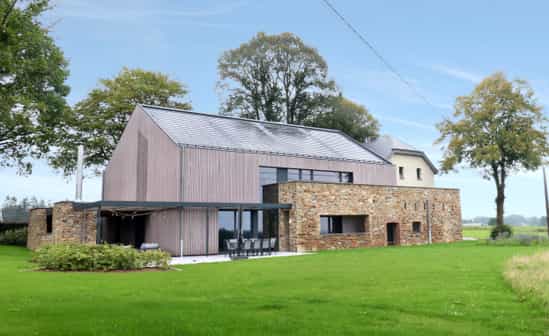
xmin=74 ymin=201 xmax=292 ymax=211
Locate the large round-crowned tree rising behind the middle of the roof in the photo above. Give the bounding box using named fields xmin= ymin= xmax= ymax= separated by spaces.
xmin=218 ymin=33 xmax=336 ymax=124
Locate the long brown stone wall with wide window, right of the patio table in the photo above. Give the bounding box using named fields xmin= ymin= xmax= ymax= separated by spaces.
xmin=278 ymin=182 xmax=462 ymax=251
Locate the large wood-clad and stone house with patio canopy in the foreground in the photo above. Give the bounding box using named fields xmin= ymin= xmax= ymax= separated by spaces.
xmin=29 ymin=105 xmax=461 ymax=255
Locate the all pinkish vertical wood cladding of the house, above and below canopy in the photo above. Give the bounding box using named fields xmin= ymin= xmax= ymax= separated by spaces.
xmin=103 ymin=107 xmax=396 ymax=255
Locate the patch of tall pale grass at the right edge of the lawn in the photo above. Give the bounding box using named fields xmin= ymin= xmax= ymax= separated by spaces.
xmin=504 ymin=251 xmax=549 ymax=308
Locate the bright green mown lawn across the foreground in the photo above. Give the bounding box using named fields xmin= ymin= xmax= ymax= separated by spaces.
xmin=0 ymin=242 xmax=549 ymax=336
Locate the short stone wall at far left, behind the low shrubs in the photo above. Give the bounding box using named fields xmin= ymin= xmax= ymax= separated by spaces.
xmin=27 ymin=202 xmax=96 ymax=250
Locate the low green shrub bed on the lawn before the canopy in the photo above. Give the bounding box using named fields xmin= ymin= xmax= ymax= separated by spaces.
xmin=32 ymin=244 xmax=170 ymax=271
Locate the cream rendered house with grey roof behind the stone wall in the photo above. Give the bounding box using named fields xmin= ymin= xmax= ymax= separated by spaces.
xmin=364 ymin=135 xmax=438 ymax=187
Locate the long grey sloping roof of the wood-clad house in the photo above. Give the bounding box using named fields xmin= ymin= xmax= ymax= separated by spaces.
xmin=140 ymin=105 xmax=390 ymax=164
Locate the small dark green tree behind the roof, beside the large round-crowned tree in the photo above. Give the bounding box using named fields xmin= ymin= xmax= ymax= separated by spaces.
xmin=311 ymin=96 xmax=379 ymax=142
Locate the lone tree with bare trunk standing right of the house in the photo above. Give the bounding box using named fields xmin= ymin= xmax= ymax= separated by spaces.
xmin=438 ymin=73 xmax=549 ymax=226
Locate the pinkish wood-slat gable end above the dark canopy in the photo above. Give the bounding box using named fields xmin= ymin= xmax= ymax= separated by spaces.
xmin=103 ymin=107 xmax=180 ymax=201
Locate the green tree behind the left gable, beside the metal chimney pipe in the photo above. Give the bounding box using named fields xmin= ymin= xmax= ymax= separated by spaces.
xmin=50 ymin=68 xmax=191 ymax=175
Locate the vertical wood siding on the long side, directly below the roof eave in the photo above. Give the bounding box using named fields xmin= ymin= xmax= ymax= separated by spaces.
xmin=183 ymin=148 xmax=396 ymax=202
